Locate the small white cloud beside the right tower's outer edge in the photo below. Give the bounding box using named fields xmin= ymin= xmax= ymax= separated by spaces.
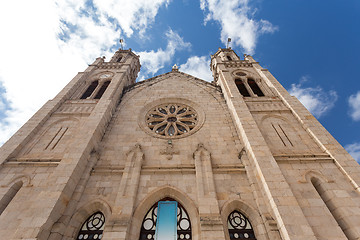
xmin=289 ymin=77 xmax=338 ymax=118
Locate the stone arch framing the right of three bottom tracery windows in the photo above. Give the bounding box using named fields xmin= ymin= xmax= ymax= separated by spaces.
xmin=220 ymin=199 xmax=268 ymax=240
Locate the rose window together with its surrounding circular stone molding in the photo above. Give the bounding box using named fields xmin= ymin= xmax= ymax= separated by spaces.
xmin=139 ymin=98 xmax=205 ymax=139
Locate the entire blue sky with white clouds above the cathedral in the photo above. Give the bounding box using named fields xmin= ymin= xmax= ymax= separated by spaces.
xmin=0 ymin=0 xmax=360 ymax=161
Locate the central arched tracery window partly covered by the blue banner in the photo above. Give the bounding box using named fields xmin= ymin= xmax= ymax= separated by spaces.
xmin=139 ymin=198 xmax=192 ymax=240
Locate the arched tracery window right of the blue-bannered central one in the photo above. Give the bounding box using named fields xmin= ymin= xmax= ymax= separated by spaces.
xmin=227 ymin=210 xmax=256 ymax=240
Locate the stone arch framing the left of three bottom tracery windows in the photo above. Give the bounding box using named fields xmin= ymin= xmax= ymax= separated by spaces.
xmin=63 ymin=199 xmax=112 ymax=239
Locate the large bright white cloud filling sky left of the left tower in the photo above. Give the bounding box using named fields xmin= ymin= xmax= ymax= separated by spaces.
xmin=0 ymin=0 xmax=169 ymax=145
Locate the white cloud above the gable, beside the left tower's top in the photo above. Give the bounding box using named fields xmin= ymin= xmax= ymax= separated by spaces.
xmin=136 ymin=29 xmax=191 ymax=80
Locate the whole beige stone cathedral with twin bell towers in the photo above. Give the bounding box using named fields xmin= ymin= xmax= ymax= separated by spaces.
xmin=0 ymin=48 xmax=360 ymax=240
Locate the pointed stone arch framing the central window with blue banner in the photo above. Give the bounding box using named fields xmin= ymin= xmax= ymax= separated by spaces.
xmin=128 ymin=186 xmax=200 ymax=240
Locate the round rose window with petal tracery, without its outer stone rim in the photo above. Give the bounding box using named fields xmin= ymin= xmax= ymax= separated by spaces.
xmin=146 ymin=104 xmax=198 ymax=137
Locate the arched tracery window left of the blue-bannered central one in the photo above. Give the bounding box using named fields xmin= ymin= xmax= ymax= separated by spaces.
xmin=76 ymin=212 xmax=105 ymax=240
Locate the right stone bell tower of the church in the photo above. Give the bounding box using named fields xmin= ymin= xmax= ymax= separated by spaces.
xmin=211 ymin=48 xmax=360 ymax=239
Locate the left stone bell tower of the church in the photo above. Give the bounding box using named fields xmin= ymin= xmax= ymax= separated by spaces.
xmin=0 ymin=49 xmax=140 ymax=239
